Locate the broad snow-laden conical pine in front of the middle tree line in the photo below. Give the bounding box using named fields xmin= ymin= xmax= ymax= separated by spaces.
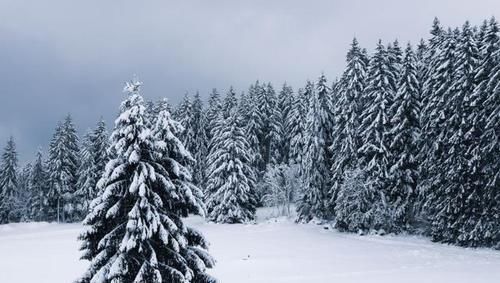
xmin=206 ymin=112 xmax=257 ymax=223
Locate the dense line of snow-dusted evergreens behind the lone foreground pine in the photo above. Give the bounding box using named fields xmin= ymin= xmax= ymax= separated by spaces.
xmin=0 ymin=18 xmax=500 ymax=251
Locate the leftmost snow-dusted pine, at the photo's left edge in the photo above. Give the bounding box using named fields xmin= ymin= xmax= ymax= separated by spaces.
xmin=0 ymin=136 xmax=19 ymax=224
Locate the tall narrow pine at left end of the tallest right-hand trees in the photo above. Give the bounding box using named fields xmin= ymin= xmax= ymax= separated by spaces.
xmin=328 ymin=38 xmax=367 ymax=222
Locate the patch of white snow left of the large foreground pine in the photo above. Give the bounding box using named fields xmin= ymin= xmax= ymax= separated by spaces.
xmin=0 ymin=223 xmax=87 ymax=283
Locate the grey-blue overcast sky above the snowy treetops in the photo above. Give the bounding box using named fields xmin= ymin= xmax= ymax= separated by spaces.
xmin=0 ymin=0 xmax=500 ymax=160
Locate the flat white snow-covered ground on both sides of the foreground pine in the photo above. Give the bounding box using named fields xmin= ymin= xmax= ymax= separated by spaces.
xmin=0 ymin=209 xmax=500 ymax=283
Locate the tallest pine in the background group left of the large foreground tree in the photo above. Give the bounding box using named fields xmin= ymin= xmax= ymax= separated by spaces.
xmin=48 ymin=115 xmax=79 ymax=222
